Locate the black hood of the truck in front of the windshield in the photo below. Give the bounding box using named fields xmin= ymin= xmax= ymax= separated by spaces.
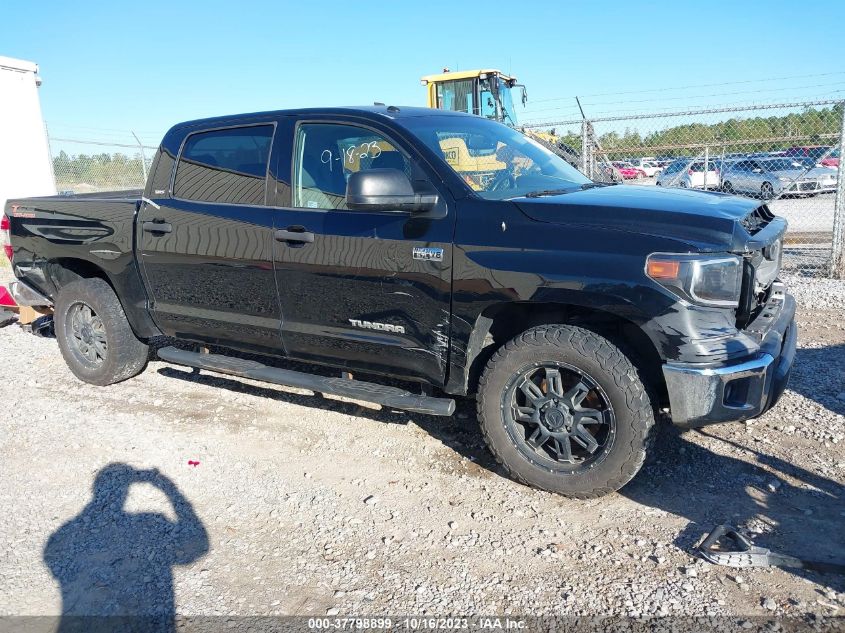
xmin=512 ymin=185 xmax=761 ymax=250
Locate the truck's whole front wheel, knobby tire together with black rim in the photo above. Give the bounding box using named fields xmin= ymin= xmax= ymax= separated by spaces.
xmin=478 ymin=325 xmax=655 ymax=499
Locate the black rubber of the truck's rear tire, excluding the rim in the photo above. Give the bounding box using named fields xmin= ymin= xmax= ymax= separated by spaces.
xmin=54 ymin=278 xmax=149 ymax=386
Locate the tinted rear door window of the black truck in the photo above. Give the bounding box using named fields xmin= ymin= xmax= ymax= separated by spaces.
xmin=173 ymin=125 xmax=273 ymax=205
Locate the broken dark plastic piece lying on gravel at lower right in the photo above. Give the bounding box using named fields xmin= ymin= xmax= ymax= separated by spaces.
xmin=698 ymin=525 xmax=845 ymax=574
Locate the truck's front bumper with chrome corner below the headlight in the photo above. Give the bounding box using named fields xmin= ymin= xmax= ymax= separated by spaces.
xmin=663 ymin=283 xmax=798 ymax=428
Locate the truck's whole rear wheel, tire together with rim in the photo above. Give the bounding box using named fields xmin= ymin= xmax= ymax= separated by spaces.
xmin=54 ymin=278 xmax=149 ymax=386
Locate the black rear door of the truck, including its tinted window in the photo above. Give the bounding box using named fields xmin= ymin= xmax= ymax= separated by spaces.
xmin=137 ymin=121 xmax=281 ymax=351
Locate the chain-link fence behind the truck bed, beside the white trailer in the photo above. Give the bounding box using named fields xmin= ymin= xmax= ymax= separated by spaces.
xmin=50 ymin=134 xmax=156 ymax=193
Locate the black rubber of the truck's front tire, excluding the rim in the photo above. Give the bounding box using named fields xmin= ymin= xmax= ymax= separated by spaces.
xmin=477 ymin=325 xmax=656 ymax=499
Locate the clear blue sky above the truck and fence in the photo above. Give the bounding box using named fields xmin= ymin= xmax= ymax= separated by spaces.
xmin=0 ymin=0 xmax=845 ymax=145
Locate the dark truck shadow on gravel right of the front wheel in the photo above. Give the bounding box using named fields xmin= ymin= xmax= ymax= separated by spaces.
xmin=620 ymin=427 xmax=845 ymax=592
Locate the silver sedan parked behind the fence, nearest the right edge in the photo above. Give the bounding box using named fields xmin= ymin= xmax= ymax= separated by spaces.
xmin=722 ymin=158 xmax=836 ymax=200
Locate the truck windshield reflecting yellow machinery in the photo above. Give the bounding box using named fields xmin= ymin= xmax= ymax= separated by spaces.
xmin=401 ymin=115 xmax=591 ymax=200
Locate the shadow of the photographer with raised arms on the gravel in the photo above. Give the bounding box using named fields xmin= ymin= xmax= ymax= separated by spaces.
xmin=44 ymin=464 xmax=208 ymax=633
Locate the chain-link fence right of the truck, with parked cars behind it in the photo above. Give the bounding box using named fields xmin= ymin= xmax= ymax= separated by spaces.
xmin=525 ymin=101 xmax=845 ymax=277
